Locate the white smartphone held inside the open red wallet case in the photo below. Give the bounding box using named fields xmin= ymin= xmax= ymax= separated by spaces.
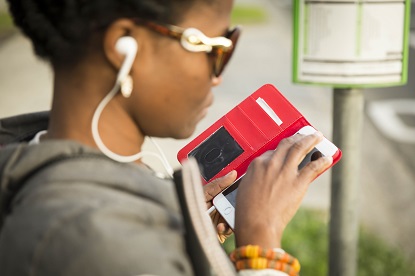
xmin=213 ymin=126 xmax=339 ymax=229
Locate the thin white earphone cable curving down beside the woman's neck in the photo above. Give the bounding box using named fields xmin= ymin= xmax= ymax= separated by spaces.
xmin=91 ymin=81 xmax=173 ymax=177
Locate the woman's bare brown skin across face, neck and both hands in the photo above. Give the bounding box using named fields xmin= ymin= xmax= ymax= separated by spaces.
xmin=44 ymin=0 xmax=332 ymax=248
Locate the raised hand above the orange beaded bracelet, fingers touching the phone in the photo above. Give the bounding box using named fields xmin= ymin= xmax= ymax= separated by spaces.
xmin=234 ymin=132 xmax=333 ymax=248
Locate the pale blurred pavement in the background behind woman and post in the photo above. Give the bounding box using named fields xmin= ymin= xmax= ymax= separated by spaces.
xmin=0 ymin=0 xmax=415 ymax=257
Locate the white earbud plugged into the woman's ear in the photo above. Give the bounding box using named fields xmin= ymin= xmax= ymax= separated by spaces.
xmin=115 ymin=36 xmax=138 ymax=83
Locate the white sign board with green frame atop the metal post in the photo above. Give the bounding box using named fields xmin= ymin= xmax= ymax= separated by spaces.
xmin=293 ymin=0 xmax=411 ymax=87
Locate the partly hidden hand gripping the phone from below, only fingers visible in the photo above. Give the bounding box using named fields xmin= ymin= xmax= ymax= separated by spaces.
xmin=203 ymin=171 xmax=237 ymax=243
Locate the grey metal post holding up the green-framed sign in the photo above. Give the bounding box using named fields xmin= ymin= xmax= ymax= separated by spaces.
xmin=329 ymin=89 xmax=364 ymax=276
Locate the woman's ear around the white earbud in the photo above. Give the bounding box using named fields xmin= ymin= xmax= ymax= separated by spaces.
xmin=103 ymin=19 xmax=137 ymax=71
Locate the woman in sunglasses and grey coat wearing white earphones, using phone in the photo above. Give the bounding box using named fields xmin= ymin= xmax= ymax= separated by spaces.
xmin=0 ymin=0 xmax=332 ymax=276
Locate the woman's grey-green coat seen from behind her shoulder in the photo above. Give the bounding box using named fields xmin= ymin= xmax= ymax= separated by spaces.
xmin=0 ymin=141 xmax=198 ymax=276
